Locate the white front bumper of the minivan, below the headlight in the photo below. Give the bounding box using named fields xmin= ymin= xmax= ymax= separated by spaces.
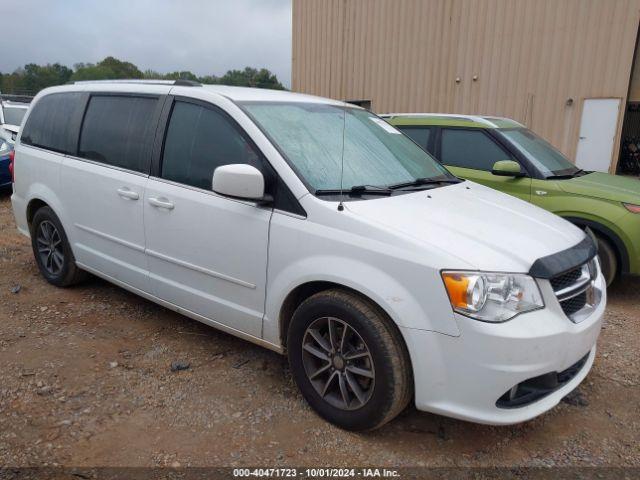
xmin=401 ymin=275 xmax=606 ymax=425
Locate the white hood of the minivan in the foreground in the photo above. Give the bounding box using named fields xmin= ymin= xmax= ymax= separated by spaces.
xmin=346 ymin=181 xmax=585 ymax=273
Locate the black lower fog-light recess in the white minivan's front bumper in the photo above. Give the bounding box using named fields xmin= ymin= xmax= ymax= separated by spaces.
xmin=496 ymin=353 xmax=589 ymax=408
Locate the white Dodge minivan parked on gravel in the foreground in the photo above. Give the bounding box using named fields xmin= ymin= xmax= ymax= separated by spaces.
xmin=12 ymin=81 xmax=605 ymax=430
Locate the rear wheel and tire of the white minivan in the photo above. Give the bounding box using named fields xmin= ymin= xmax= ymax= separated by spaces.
xmin=30 ymin=207 xmax=87 ymax=287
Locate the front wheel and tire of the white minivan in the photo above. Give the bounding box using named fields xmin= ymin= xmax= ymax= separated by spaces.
xmin=287 ymin=289 xmax=413 ymax=431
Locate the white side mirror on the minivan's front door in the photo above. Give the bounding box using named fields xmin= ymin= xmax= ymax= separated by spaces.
xmin=211 ymin=163 xmax=270 ymax=202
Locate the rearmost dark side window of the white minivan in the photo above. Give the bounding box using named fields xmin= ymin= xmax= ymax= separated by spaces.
xmin=21 ymin=92 xmax=83 ymax=155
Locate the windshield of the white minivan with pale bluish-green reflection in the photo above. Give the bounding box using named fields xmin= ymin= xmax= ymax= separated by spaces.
xmin=242 ymin=102 xmax=455 ymax=194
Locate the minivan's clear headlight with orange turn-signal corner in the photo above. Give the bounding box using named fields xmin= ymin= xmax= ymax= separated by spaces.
xmin=442 ymin=271 xmax=544 ymax=322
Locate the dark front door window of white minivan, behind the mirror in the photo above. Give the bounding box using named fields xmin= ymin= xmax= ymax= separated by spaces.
xmin=162 ymin=102 xmax=261 ymax=190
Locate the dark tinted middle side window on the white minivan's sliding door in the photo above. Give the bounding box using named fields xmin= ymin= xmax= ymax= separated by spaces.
xmin=78 ymin=95 xmax=158 ymax=173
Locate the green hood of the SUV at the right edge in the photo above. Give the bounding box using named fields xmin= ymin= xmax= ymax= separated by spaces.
xmin=556 ymin=172 xmax=640 ymax=205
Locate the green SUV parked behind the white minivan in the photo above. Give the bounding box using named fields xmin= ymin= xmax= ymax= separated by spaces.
xmin=383 ymin=114 xmax=640 ymax=284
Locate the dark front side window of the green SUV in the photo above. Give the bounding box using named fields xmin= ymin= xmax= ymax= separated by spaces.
xmin=440 ymin=128 xmax=513 ymax=172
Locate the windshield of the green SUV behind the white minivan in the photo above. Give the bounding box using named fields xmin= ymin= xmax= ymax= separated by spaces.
xmin=499 ymin=128 xmax=581 ymax=178
